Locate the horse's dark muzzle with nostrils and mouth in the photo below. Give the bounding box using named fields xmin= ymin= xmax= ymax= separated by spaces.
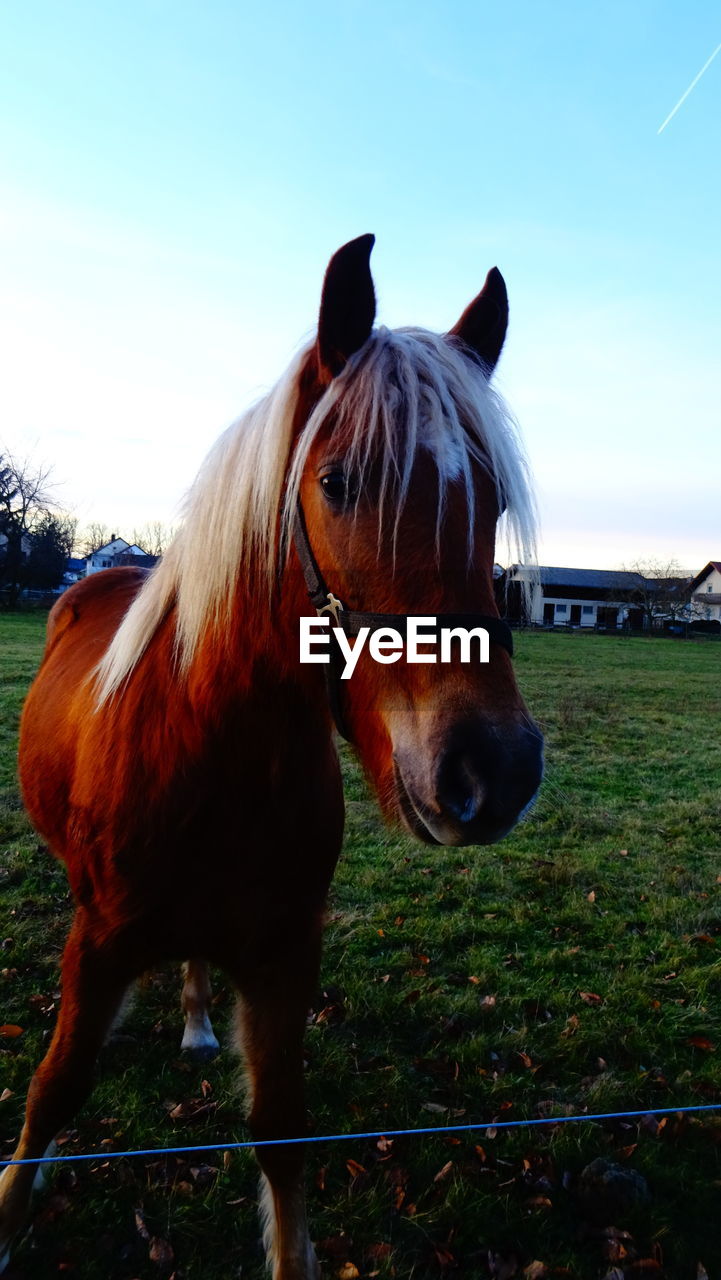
xmin=393 ymin=721 xmax=543 ymax=845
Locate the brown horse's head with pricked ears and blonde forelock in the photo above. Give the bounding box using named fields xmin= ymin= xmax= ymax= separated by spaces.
xmin=288 ymin=236 xmax=542 ymax=845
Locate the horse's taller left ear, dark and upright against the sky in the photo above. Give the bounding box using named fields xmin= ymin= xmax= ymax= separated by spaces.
xmin=318 ymin=236 xmax=375 ymax=378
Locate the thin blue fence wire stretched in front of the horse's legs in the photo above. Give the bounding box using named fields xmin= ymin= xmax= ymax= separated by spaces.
xmin=0 ymin=1102 xmax=721 ymax=1169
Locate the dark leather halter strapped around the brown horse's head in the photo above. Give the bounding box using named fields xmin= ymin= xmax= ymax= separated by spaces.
xmin=293 ymin=499 xmax=514 ymax=742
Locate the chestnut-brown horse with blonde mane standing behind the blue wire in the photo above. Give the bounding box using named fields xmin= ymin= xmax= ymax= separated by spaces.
xmin=0 ymin=236 xmax=542 ymax=1280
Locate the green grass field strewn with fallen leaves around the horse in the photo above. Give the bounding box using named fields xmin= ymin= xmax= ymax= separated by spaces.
xmin=0 ymin=616 xmax=721 ymax=1280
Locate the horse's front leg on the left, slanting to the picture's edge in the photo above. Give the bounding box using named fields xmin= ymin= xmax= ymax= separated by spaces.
xmin=0 ymin=913 xmax=134 ymax=1271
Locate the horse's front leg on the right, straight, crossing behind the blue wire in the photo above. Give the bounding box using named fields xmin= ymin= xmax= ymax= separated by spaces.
xmin=234 ymin=956 xmax=319 ymax=1280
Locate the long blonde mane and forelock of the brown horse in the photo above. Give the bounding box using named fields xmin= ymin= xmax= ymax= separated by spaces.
xmin=97 ymin=320 xmax=535 ymax=703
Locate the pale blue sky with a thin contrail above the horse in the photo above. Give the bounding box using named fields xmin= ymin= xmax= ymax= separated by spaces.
xmin=0 ymin=0 xmax=721 ymax=570
